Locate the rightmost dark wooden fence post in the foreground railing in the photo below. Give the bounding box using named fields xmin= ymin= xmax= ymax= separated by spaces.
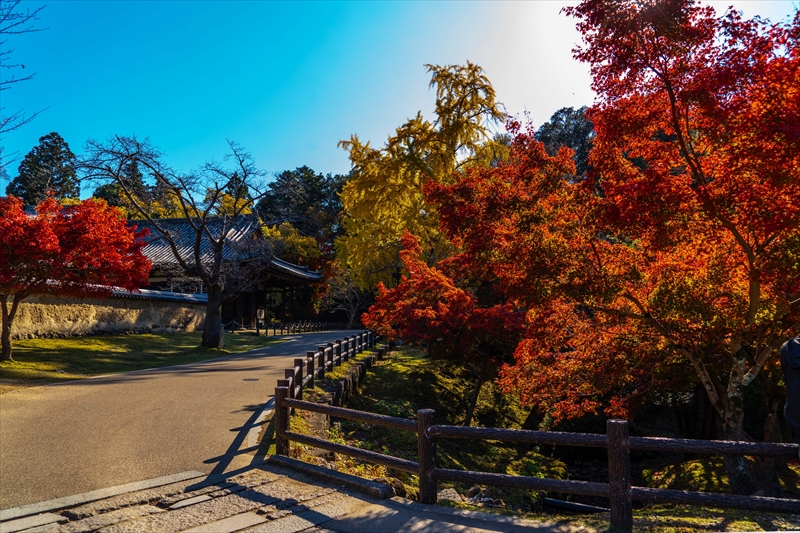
xmin=606 ymin=420 xmax=633 ymax=532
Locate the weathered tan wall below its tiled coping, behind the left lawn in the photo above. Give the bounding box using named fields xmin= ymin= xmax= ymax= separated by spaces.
xmin=11 ymin=296 xmax=206 ymax=339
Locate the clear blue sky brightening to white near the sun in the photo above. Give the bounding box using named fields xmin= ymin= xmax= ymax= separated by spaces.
xmin=0 ymin=0 xmax=798 ymax=196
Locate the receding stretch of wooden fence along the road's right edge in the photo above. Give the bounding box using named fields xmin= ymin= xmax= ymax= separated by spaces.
xmin=278 ymin=331 xmax=386 ymax=400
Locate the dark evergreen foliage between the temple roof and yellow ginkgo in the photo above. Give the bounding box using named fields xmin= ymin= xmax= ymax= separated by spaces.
xmin=256 ymin=166 xmax=346 ymax=250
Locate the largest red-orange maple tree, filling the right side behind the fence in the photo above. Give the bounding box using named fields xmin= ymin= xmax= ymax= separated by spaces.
xmin=418 ymin=0 xmax=800 ymax=490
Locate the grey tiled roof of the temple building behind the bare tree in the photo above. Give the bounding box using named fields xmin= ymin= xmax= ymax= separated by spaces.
xmin=131 ymin=215 xmax=322 ymax=283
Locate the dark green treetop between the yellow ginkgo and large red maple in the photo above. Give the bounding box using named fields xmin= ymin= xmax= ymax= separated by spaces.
xmin=536 ymin=106 xmax=595 ymax=178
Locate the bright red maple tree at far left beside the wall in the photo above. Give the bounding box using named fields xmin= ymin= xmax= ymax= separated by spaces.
xmin=0 ymin=196 xmax=150 ymax=361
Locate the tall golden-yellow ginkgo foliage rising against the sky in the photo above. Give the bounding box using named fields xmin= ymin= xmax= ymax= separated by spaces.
xmin=336 ymin=63 xmax=508 ymax=288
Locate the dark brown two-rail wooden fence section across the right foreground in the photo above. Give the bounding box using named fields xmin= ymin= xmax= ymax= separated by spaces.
xmin=275 ymin=396 xmax=800 ymax=531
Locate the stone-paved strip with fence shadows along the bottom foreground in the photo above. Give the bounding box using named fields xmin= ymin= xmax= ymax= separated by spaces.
xmin=0 ymin=463 xmax=585 ymax=533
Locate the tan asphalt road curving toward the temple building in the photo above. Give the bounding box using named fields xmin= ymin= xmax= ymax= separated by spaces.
xmin=0 ymin=331 xmax=352 ymax=509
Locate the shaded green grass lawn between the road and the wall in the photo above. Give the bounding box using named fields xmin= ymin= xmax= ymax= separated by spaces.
xmin=0 ymin=332 xmax=282 ymax=393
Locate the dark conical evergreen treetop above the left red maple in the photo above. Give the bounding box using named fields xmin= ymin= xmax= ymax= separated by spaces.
xmin=6 ymin=132 xmax=81 ymax=206
